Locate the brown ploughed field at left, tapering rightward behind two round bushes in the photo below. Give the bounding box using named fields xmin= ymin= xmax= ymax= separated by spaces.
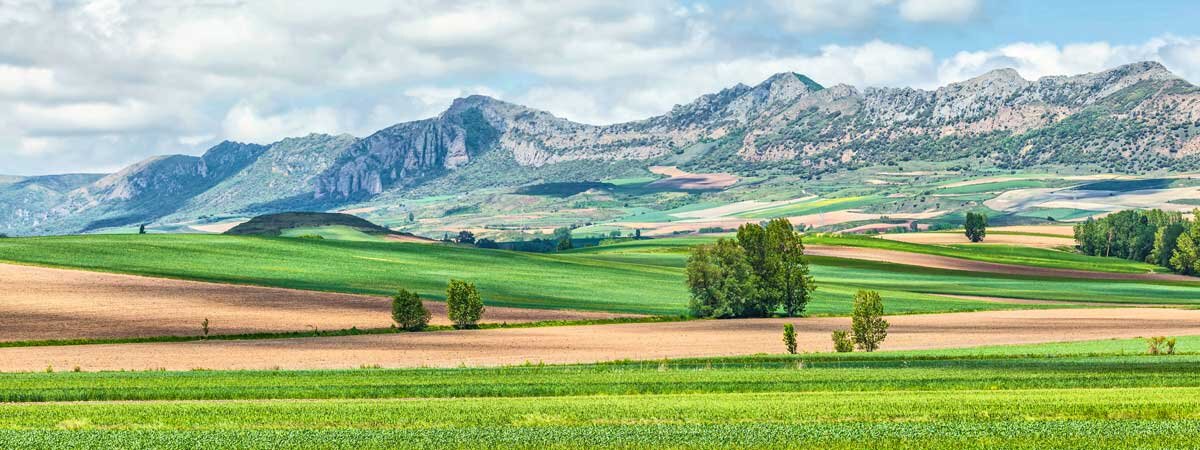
xmin=0 ymin=264 xmax=638 ymax=341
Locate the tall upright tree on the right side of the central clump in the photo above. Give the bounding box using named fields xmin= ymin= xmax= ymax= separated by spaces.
xmin=766 ymin=218 xmax=816 ymax=317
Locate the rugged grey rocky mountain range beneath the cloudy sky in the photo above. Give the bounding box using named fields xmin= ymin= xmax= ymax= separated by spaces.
xmin=0 ymin=62 xmax=1200 ymax=235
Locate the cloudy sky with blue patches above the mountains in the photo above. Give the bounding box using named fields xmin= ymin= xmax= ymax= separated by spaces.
xmin=0 ymin=0 xmax=1200 ymax=175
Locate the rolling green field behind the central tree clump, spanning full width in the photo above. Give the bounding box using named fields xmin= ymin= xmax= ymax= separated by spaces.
xmin=0 ymin=234 xmax=1200 ymax=316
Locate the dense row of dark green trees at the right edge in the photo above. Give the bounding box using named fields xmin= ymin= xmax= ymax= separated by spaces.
xmin=1075 ymin=209 xmax=1200 ymax=275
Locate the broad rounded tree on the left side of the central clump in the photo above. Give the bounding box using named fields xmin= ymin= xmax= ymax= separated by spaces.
xmin=686 ymin=239 xmax=755 ymax=318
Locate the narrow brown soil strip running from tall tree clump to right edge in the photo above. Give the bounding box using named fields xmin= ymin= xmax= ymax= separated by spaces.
xmin=804 ymin=245 xmax=1185 ymax=282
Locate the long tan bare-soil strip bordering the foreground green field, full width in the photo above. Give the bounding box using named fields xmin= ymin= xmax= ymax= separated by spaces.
xmin=0 ymin=308 xmax=1200 ymax=372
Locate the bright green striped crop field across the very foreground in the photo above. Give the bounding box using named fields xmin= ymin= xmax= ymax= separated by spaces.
xmin=0 ymin=338 xmax=1200 ymax=449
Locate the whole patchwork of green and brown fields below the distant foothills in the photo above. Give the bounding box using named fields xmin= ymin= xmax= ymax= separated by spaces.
xmin=0 ymin=203 xmax=1200 ymax=449
